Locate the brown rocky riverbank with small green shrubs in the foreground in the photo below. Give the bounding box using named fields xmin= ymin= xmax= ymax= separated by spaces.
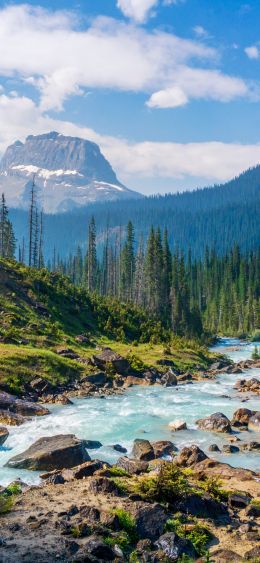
xmin=0 ymin=437 xmax=260 ymax=563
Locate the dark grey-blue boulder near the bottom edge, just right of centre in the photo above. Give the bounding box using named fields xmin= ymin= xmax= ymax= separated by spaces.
xmin=155 ymin=532 xmax=198 ymax=561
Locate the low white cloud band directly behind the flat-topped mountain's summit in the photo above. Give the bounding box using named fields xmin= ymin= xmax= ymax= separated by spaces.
xmin=0 ymin=94 xmax=260 ymax=193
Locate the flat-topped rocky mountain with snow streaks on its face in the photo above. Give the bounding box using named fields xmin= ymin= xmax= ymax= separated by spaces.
xmin=0 ymin=131 xmax=142 ymax=213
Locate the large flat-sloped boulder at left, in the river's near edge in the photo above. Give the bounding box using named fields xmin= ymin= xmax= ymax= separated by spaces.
xmin=6 ymin=434 xmax=90 ymax=471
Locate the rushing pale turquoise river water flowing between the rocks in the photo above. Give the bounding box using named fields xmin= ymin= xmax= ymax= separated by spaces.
xmin=0 ymin=338 xmax=260 ymax=485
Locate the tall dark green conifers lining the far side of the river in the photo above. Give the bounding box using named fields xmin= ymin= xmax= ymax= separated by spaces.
xmin=0 ymin=192 xmax=260 ymax=337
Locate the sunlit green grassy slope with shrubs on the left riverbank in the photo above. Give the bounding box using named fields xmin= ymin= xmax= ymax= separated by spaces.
xmin=0 ymin=260 xmax=215 ymax=392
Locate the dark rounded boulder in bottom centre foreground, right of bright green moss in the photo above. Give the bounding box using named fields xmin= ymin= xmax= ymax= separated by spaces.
xmin=131 ymin=502 xmax=168 ymax=541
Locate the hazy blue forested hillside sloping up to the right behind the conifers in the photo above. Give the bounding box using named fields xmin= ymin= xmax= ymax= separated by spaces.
xmin=11 ymin=166 xmax=260 ymax=259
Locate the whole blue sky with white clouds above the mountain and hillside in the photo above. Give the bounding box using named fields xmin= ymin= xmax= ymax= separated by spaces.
xmin=0 ymin=0 xmax=260 ymax=194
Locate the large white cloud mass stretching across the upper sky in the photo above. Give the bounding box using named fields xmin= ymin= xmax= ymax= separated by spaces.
xmin=0 ymin=4 xmax=256 ymax=111
